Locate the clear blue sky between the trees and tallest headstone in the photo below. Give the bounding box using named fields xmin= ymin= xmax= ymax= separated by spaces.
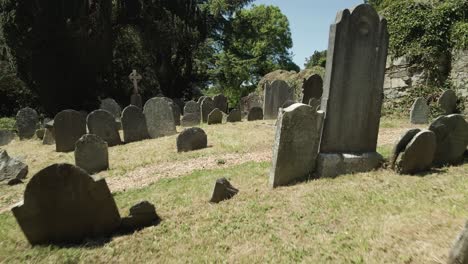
xmin=253 ymin=0 xmax=364 ymax=68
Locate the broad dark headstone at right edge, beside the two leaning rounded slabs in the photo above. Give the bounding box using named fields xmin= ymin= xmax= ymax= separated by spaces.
xmin=429 ymin=115 xmax=468 ymax=166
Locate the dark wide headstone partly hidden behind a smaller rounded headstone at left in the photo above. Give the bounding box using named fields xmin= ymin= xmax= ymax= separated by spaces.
xmin=54 ymin=110 xmax=86 ymax=152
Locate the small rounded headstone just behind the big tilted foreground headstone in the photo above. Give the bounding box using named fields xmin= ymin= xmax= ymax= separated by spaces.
xmin=75 ymin=134 xmax=109 ymax=174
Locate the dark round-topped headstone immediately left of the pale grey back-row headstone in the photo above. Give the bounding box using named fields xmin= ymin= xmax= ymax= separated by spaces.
xmin=121 ymin=105 xmax=149 ymax=143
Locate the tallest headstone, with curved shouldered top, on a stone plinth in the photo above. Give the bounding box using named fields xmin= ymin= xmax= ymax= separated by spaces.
xmin=318 ymin=4 xmax=389 ymax=177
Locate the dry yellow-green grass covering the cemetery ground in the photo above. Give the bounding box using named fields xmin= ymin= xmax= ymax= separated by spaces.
xmin=0 ymin=117 xmax=468 ymax=263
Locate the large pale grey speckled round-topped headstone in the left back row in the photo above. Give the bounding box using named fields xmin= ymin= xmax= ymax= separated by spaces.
xmin=143 ymin=97 xmax=177 ymax=138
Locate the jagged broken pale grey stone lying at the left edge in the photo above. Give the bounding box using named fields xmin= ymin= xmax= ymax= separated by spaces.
xmin=0 ymin=149 xmax=28 ymax=185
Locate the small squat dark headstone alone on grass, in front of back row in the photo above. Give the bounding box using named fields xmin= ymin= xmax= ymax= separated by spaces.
xmin=177 ymin=127 xmax=208 ymax=152
